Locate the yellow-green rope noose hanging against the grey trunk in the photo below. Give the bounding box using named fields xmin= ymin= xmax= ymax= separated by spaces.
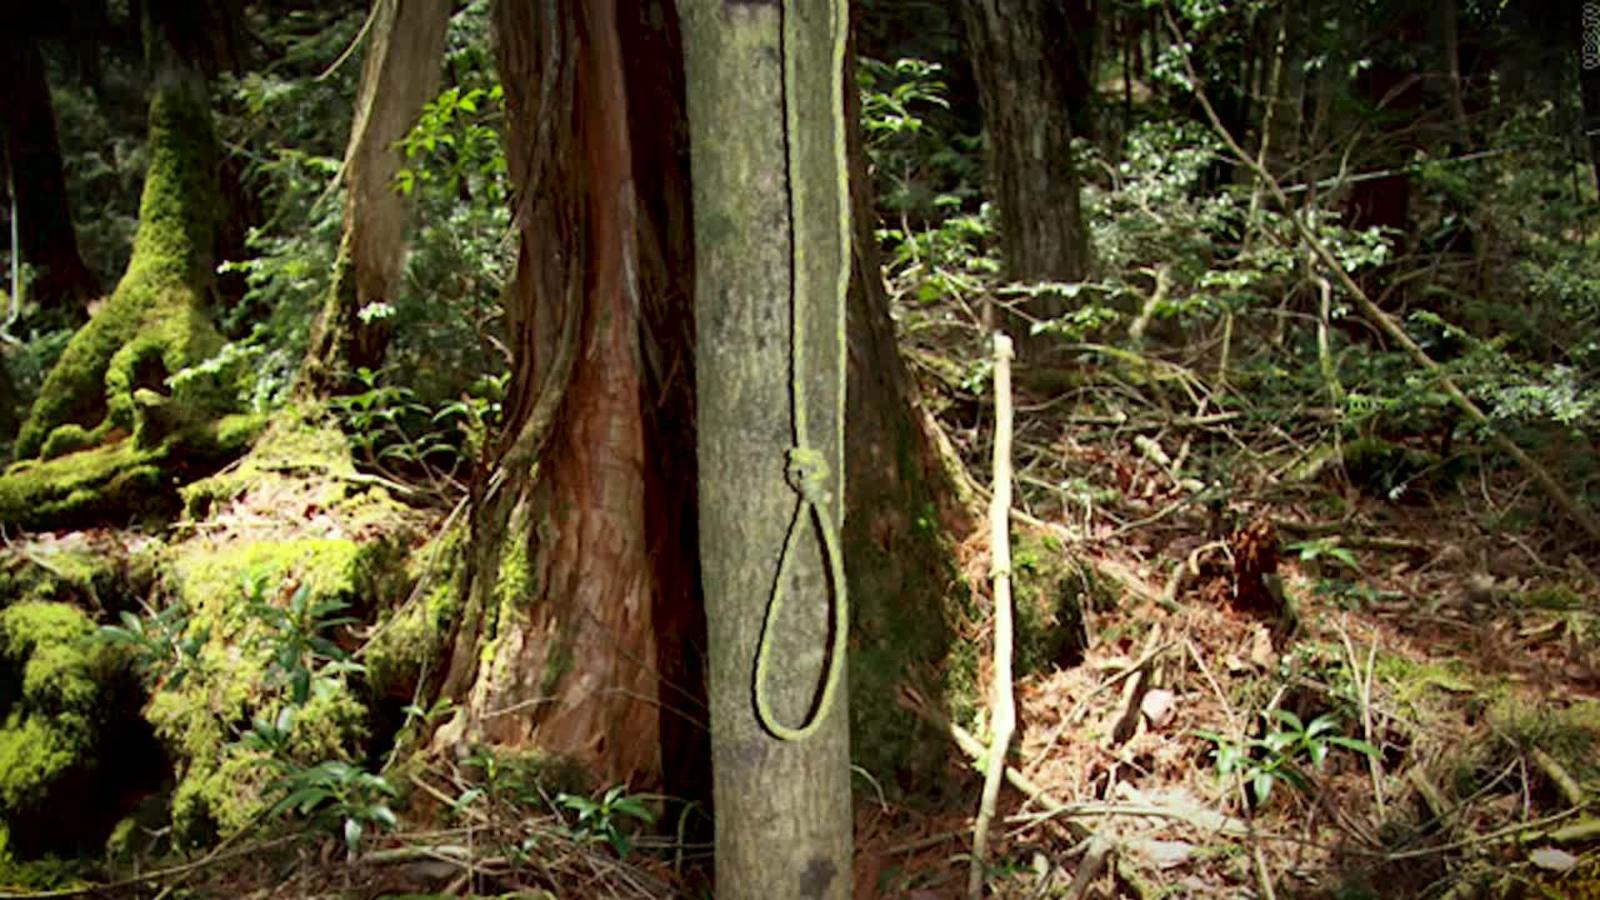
xmin=755 ymin=0 xmax=850 ymax=741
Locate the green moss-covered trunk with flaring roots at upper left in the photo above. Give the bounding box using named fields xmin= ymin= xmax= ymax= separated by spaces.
xmin=16 ymin=0 xmax=222 ymax=458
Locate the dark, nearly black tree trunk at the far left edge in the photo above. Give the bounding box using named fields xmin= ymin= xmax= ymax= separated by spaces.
xmin=0 ymin=32 xmax=99 ymax=314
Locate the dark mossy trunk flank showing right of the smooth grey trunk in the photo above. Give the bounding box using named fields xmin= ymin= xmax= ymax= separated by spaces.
xmin=843 ymin=6 xmax=971 ymax=798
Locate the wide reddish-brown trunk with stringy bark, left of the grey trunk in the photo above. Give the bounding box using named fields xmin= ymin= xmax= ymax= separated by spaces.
xmin=443 ymin=0 xmax=704 ymax=785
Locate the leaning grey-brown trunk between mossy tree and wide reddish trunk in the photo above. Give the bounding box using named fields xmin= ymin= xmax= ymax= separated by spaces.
xmin=301 ymin=0 xmax=450 ymax=394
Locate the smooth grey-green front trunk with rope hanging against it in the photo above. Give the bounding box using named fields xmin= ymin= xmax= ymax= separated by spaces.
xmin=682 ymin=0 xmax=851 ymax=898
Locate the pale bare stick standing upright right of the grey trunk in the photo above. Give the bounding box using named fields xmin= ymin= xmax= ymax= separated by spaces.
xmin=966 ymin=331 xmax=1016 ymax=900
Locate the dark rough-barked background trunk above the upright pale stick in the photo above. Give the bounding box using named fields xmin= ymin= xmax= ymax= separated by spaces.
xmin=962 ymin=0 xmax=1090 ymax=342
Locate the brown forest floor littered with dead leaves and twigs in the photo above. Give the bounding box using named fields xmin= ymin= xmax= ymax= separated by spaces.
xmin=13 ymin=336 xmax=1600 ymax=900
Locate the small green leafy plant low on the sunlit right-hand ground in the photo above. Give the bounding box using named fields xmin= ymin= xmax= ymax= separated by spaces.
xmin=1194 ymin=709 xmax=1378 ymax=804
